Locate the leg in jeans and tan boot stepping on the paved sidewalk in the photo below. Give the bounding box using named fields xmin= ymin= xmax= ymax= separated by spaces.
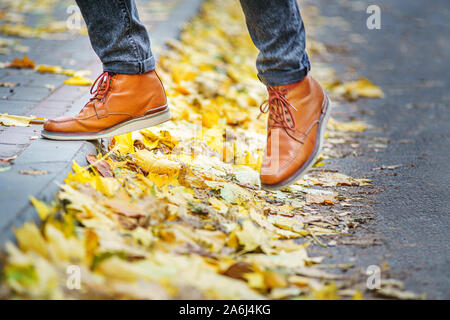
xmin=42 ymin=0 xmax=170 ymax=140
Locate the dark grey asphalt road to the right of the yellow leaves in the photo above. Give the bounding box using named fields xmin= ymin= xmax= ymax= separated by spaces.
xmin=306 ymin=0 xmax=450 ymax=299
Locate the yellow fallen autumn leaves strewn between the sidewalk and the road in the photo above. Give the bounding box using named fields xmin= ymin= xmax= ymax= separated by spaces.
xmin=3 ymin=0 xmax=422 ymax=299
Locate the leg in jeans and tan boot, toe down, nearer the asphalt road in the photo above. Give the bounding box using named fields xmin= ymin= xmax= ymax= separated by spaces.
xmin=241 ymin=0 xmax=330 ymax=189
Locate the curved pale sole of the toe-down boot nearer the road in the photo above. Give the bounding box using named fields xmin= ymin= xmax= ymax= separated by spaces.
xmin=261 ymin=96 xmax=331 ymax=190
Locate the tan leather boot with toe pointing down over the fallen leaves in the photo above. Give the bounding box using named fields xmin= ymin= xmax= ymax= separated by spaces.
xmin=260 ymin=75 xmax=330 ymax=189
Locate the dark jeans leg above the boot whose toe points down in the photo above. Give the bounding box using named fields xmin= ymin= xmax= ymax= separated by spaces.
xmin=240 ymin=0 xmax=310 ymax=87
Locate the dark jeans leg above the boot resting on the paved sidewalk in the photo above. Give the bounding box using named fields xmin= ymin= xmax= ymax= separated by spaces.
xmin=76 ymin=0 xmax=155 ymax=74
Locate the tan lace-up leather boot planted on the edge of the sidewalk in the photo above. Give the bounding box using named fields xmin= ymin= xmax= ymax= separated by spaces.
xmin=41 ymin=71 xmax=170 ymax=140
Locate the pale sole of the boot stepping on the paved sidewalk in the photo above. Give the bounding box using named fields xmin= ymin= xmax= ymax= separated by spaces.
xmin=41 ymin=105 xmax=171 ymax=141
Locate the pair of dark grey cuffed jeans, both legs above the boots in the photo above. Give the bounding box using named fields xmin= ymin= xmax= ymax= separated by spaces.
xmin=76 ymin=0 xmax=310 ymax=87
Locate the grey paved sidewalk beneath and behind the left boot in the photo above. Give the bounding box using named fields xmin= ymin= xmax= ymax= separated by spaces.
xmin=0 ymin=0 xmax=202 ymax=245
